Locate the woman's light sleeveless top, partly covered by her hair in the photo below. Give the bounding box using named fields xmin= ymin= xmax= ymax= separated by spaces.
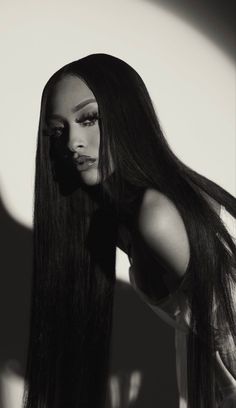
xmin=129 ymin=206 xmax=236 ymax=408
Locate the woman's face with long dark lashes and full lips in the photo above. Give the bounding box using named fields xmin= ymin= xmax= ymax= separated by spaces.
xmin=47 ymin=75 xmax=112 ymax=186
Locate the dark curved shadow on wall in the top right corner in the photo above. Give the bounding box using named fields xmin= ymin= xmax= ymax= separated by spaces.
xmin=148 ymin=0 xmax=236 ymax=60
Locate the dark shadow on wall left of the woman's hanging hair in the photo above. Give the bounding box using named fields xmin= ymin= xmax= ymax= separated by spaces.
xmin=0 ymin=196 xmax=32 ymax=408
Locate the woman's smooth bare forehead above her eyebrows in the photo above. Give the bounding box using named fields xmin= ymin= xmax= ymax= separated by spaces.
xmin=48 ymin=75 xmax=95 ymax=113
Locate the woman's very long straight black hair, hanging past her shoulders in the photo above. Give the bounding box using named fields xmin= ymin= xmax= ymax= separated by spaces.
xmin=24 ymin=54 xmax=236 ymax=408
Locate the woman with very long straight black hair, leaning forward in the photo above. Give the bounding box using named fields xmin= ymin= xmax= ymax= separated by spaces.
xmin=22 ymin=54 xmax=236 ymax=408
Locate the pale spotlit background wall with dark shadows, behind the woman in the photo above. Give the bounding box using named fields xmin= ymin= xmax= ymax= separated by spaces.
xmin=0 ymin=0 xmax=236 ymax=408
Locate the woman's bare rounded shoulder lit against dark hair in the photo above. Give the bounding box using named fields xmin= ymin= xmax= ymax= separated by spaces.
xmin=137 ymin=189 xmax=190 ymax=278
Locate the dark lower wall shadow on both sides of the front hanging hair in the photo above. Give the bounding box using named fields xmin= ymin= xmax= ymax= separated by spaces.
xmin=0 ymin=194 xmax=177 ymax=408
